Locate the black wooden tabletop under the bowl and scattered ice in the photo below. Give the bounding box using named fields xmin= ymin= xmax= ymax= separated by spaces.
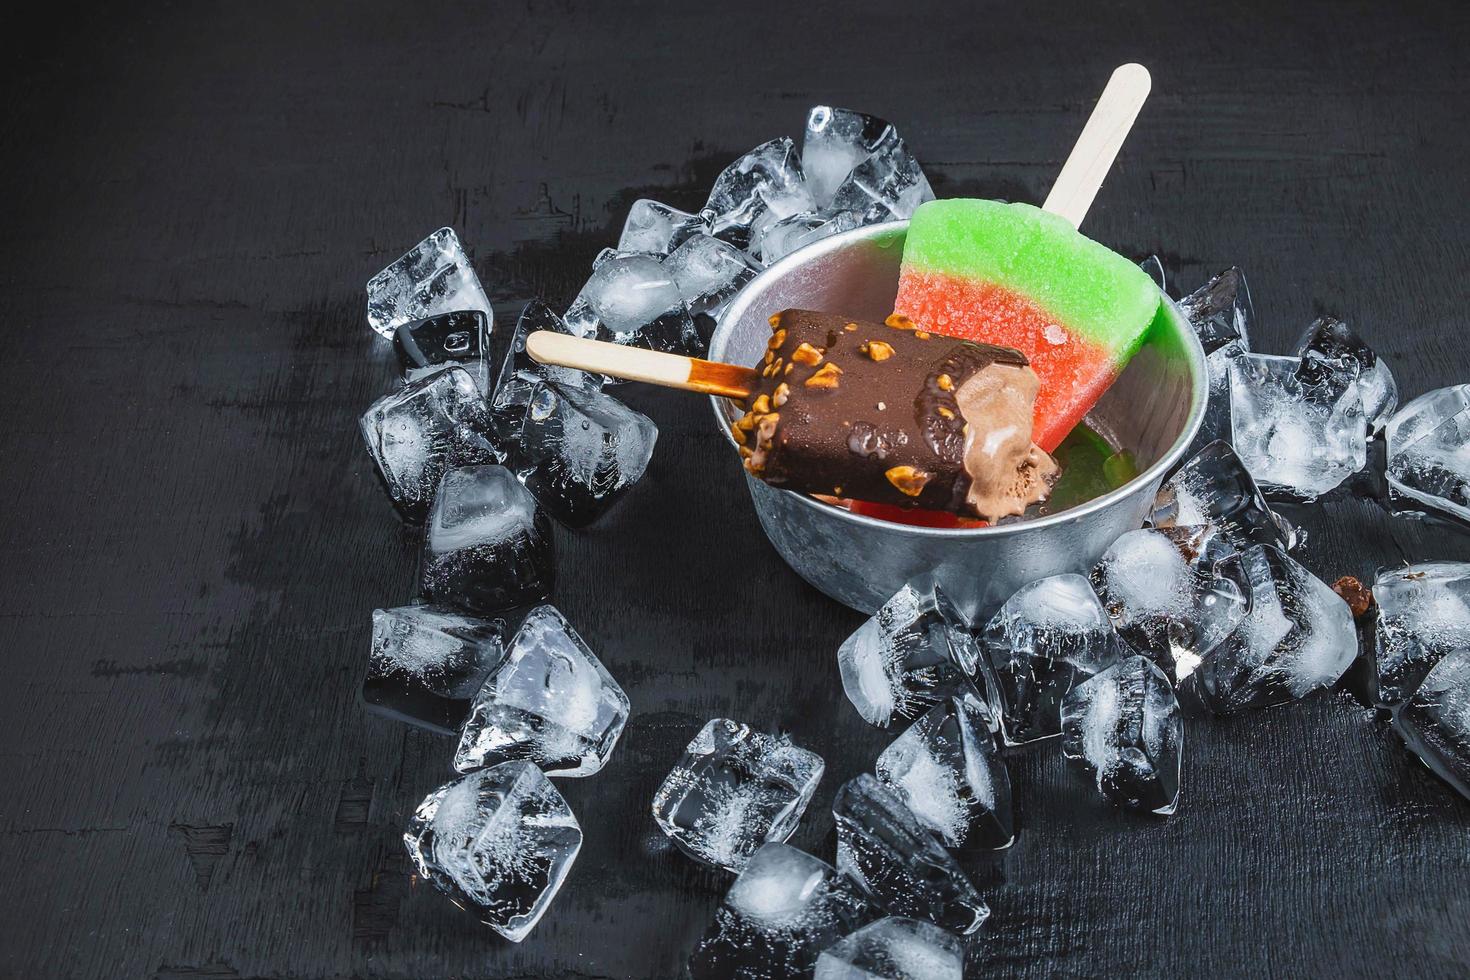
xmin=0 ymin=0 xmax=1470 ymax=980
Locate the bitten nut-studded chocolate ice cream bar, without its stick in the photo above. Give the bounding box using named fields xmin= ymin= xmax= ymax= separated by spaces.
xmin=732 ymin=310 xmax=1057 ymax=522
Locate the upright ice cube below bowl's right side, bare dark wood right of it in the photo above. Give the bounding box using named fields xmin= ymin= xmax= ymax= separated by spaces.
xmin=1061 ymin=657 xmax=1185 ymax=815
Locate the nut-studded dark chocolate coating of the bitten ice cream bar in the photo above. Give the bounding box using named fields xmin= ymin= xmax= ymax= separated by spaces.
xmin=736 ymin=310 xmax=1026 ymax=513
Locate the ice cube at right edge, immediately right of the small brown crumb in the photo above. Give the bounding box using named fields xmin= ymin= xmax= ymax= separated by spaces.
xmin=1373 ymin=561 xmax=1470 ymax=707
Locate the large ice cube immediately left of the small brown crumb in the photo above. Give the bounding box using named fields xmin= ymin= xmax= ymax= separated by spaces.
xmin=1180 ymin=545 xmax=1358 ymax=714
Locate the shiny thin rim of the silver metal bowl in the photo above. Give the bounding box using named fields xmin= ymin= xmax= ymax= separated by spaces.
xmin=710 ymin=220 xmax=1210 ymax=541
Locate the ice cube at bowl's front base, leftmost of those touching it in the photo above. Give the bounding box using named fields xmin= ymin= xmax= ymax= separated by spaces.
xmin=836 ymin=585 xmax=979 ymax=727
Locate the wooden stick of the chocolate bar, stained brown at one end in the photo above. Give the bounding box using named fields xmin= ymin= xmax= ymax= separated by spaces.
xmin=526 ymin=331 xmax=760 ymax=398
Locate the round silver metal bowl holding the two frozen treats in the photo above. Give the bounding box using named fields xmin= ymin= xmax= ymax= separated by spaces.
xmin=710 ymin=222 xmax=1210 ymax=620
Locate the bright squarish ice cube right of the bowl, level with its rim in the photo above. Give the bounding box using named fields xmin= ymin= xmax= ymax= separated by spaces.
xmin=1230 ymin=354 xmax=1367 ymax=501
